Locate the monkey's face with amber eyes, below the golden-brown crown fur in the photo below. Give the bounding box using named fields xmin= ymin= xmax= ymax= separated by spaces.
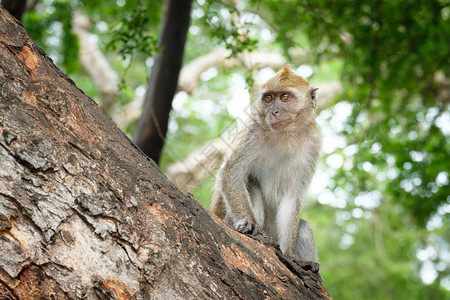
xmin=257 ymin=87 xmax=315 ymax=131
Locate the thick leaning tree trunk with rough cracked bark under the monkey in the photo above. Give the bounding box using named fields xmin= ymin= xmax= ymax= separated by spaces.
xmin=0 ymin=7 xmax=330 ymax=299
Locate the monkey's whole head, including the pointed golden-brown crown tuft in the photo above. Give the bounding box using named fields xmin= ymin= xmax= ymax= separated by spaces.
xmin=254 ymin=65 xmax=317 ymax=131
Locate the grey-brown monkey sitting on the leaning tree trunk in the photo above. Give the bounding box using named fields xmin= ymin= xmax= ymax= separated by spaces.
xmin=210 ymin=64 xmax=322 ymax=262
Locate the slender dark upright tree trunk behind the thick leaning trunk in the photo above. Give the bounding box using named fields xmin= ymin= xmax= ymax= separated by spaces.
xmin=134 ymin=0 xmax=192 ymax=163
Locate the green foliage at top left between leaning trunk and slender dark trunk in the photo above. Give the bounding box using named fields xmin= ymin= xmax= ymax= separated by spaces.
xmin=23 ymin=0 xmax=163 ymax=98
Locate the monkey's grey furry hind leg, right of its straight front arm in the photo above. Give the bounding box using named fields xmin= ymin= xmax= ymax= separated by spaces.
xmin=295 ymin=219 xmax=318 ymax=262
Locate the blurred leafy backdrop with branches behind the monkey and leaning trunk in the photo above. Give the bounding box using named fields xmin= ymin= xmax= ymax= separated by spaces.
xmin=0 ymin=0 xmax=450 ymax=299
